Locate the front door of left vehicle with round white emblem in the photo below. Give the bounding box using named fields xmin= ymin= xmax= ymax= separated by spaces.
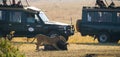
xmin=26 ymin=13 xmax=43 ymax=37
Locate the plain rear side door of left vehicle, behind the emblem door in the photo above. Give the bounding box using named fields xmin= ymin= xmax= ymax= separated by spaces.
xmin=8 ymin=11 xmax=25 ymax=36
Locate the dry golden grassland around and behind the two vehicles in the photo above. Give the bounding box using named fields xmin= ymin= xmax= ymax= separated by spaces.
xmin=9 ymin=0 xmax=120 ymax=57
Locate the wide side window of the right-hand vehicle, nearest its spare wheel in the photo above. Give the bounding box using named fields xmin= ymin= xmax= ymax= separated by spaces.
xmin=87 ymin=12 xmax=112 ymax=22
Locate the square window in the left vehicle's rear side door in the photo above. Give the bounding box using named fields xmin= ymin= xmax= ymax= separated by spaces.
xmin=10 ymin=12 xmax=21 ymax=23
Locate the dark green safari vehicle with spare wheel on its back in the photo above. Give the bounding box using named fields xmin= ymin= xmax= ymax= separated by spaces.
xmin=76 ymin=0 xmax=120 ymax=43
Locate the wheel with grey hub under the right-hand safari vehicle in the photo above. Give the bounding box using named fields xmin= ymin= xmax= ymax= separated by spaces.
xmin=98 ymin=32 xmax=110 ymax=43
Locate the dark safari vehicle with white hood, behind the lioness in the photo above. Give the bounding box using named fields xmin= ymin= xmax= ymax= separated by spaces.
xmin=0 ymin=1 xmax=74 ymax=40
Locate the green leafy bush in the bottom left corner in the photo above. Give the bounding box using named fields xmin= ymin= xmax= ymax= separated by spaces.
xmin=0 ymin=38 xmax=25 ymax=57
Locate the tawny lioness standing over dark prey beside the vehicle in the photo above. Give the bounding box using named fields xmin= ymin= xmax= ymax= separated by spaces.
xmin=35 ymin=34 xmax=66 ymax=50
